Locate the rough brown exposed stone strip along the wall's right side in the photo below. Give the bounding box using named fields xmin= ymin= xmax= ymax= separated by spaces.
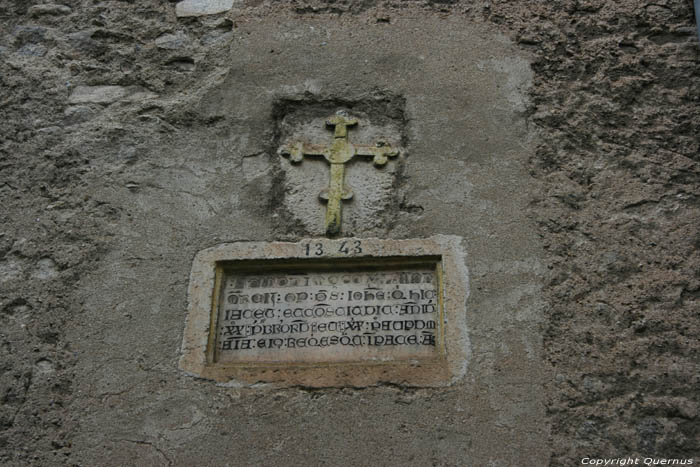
xmin=483 ymin=1 xmax=700 ymax=465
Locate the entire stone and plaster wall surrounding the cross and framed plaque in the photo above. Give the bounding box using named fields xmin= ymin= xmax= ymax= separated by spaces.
xmin=0 ymin=0 xmax=700 ymax=466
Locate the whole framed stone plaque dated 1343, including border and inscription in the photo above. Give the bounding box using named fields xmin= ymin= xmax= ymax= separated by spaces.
xmin=180 ymin=236 xmax=469 ymax=387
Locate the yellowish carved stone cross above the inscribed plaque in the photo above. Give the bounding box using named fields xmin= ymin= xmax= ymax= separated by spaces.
xmin=280 ymin=115 xmax=399 ymax=236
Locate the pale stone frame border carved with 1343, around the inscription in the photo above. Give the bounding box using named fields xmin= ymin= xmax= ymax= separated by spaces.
xmin=179 ymin=235 xmax=470 ymax=387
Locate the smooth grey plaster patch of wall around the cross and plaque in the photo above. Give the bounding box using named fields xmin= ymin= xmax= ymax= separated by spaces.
xmin=60 ymin=15 xmax=548 ymax=465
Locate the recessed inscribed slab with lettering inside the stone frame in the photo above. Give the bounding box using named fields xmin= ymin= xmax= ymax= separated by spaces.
xmin=214 ymin=265 xmax=441 ymax=363
